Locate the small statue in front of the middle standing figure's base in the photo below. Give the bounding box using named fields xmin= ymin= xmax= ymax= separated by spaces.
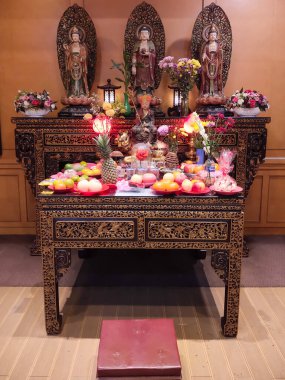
xmin=132 ymin=94 xmax=157 ymax=145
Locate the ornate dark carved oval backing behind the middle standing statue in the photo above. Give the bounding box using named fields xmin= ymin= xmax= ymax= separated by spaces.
xmin=125 ymin=1 xmax=165 ymax=93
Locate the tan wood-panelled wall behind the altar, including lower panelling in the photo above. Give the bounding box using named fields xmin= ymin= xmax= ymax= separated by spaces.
xmin=0 ymin=0 xmax=285 ymax=234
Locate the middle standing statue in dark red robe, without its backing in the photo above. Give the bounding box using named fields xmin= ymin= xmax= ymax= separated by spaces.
xmin=132 ymin=25 xmax=156 ymax=96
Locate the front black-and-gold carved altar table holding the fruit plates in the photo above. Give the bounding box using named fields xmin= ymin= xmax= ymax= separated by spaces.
xmin=37 ymin=189 xmax=244 ymax=337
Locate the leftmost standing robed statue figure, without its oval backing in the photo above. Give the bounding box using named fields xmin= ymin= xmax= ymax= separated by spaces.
xmin=63 ymin=26 xmax=89 ymax=97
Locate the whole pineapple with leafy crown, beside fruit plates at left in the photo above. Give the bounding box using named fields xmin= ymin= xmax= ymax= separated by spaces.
xmin=94 ymin=134 xmax=117 ymax=183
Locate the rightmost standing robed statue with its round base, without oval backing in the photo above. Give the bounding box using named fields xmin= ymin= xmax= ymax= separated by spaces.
xmin=197 ymin=24 xmax=226 ymax=104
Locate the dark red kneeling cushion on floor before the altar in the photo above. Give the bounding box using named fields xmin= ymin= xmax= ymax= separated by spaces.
xmin=97 ymin=319 xmax=181 ymax=379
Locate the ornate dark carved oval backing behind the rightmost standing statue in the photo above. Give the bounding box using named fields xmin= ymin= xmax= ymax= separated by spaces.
xmin=191 ymin=3 xmax=232 ymax=95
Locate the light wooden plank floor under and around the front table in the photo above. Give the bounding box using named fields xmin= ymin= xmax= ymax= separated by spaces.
xmin=0 ymin=287 xmax=285 ymax=380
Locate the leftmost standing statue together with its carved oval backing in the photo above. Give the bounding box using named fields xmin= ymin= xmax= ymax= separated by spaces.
xmin=57 ymin=4 xmax=97 ymax=98
